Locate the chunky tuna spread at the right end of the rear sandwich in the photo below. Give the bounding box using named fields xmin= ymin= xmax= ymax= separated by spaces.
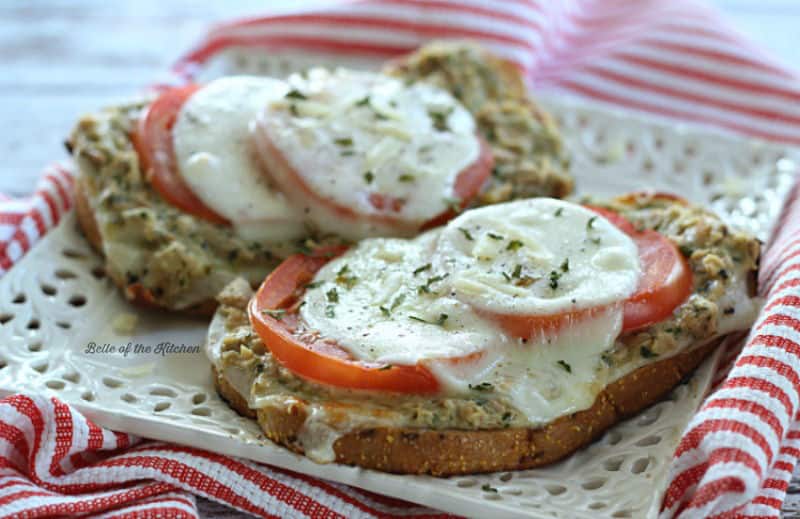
xmin=386 ymin=41 xmax=573 ymax=204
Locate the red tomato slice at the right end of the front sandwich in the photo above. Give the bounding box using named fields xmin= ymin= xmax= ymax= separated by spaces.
xmin=483 ymin=206 xmax=693 ymax=338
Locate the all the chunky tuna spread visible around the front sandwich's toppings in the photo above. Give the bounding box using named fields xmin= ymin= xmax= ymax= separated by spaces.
xmin=209 ymin=195 xmax=759 ymax=461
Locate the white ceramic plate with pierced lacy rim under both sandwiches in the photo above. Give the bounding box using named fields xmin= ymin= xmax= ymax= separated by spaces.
xmin=0 ymin=51 xmax=800 ymax=518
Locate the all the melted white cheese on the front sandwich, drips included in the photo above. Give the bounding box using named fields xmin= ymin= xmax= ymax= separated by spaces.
xmin=300 ymin=199 xmax=639 ymax=424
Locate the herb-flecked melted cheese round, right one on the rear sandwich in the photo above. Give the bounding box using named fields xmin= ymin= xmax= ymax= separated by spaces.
xmin=256 ymin=69 xmax=481 ymax=239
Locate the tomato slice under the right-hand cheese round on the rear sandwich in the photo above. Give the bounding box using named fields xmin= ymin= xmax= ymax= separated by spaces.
xmin=258 ymin=125 xmax=494 ymax=230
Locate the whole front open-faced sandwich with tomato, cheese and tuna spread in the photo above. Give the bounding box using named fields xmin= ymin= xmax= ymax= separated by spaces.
xmin=208 ymin=194 xmax=759 ymax=475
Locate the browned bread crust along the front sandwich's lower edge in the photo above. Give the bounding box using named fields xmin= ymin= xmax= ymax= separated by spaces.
xmin=214 ymin=340 xmax=718 ymax=476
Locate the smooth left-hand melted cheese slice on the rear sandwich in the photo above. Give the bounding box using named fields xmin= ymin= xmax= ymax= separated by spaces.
xmin=172 ymin=76 xmax=305 ymax=242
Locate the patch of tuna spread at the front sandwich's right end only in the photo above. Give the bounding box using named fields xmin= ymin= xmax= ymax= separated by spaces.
xmin=595 ymin=193 xmax=761 ymax=378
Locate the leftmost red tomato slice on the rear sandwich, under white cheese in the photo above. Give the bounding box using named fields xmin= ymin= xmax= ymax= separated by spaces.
xmin=132 ymin=85 xmax=230 ymax=225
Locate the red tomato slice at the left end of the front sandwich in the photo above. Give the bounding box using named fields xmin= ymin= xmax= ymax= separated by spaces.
xmin=249 ymin=249 xmax=439 ymax=394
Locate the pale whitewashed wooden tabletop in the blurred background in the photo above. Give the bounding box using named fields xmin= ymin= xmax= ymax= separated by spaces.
xmin=0 ymin=0 xmax=800 ymax=518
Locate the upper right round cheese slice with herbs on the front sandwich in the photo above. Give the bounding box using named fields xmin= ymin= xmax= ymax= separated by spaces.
xmin=433 ymin=198 xmax=641 ymax=315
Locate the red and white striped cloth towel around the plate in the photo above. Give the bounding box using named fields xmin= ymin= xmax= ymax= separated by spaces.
xmin=0 ymin=0 xmax=800 ymax=517
